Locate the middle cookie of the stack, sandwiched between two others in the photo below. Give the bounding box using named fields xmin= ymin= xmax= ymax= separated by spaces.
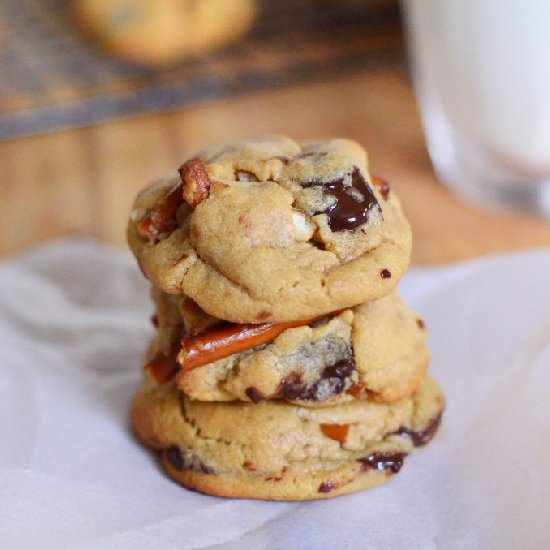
xmin=148 ymin=290 xmax=429 ymax=406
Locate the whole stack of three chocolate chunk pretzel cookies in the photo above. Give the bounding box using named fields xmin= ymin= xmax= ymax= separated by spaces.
xmin=128 ymin=137 xmax=444 ymax=500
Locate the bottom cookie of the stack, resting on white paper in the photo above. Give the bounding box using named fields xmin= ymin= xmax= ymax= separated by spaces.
xmin=132 ymin=380 xmax=444 ymax=500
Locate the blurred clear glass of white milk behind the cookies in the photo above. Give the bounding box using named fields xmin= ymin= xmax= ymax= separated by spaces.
xmin=403 ymin=0 xmax=550 ymax=216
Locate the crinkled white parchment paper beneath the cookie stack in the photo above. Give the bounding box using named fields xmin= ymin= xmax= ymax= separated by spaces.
xmin=0 ymin=240 xmax=550 ymax=550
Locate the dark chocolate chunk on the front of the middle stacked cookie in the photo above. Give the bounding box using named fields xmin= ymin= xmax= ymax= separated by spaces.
xmin=278 ymin=355 xmax=355 ymax=401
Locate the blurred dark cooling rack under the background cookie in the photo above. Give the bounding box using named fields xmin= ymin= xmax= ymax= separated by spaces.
xmin=0 ymin=0 xmax=403 ymax=139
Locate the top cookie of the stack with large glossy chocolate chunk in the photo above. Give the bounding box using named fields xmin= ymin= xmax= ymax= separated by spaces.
xmin=128 ymin=137 xmax=411 ymax=323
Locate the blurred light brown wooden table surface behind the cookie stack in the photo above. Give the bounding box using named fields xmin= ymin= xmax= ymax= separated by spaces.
xmin=0 ymin=71 xmax=550 ymax=264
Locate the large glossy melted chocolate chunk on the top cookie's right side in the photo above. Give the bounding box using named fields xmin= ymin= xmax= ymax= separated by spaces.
xmin=302 ymin=168 xmax=382 ymax=231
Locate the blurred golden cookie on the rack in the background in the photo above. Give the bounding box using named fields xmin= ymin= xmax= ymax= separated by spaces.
xmin=73 ymin=0 xmax=257 ymax=65
